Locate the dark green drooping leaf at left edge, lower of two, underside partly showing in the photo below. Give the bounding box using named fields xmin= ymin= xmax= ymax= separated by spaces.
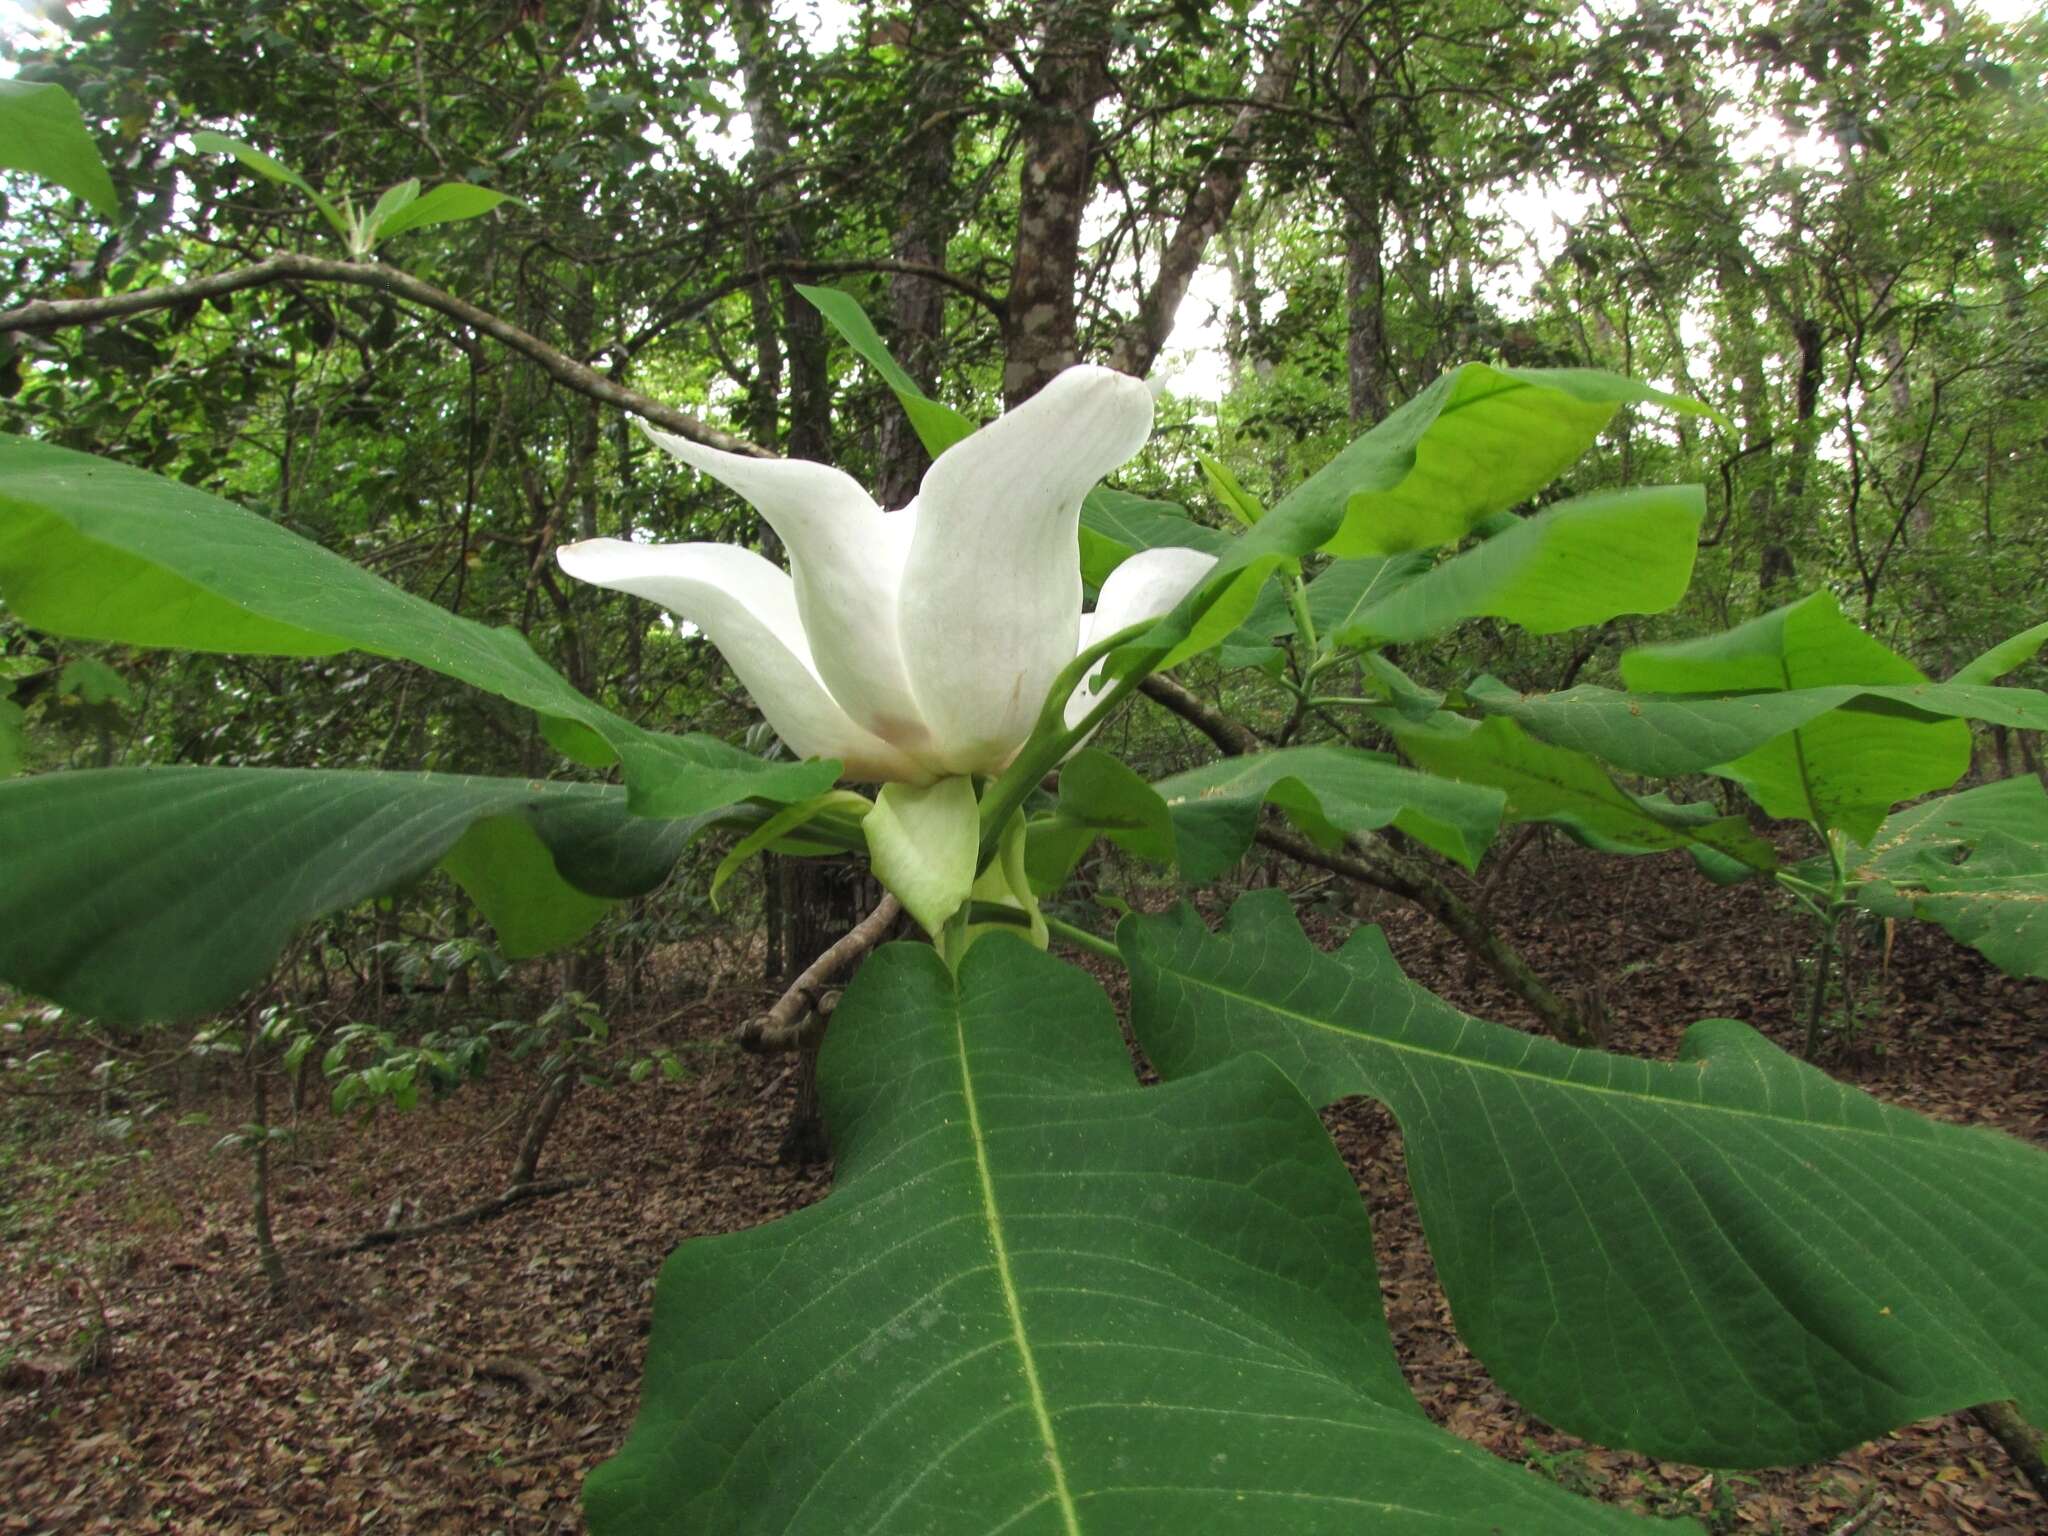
xmin=0 ymin=768 xmax=700 ymax=1020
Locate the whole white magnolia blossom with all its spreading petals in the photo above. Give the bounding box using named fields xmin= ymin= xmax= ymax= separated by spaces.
xmin=555 ymin=367 xmax=1214 ymax=784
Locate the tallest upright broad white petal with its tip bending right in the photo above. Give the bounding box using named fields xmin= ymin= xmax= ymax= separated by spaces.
xmin=899 ymin=367 xmax=1153 ymax=774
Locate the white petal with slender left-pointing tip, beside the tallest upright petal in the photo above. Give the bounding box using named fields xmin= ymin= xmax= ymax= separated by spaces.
xmin=641 ymin=424 xmax=930 ymax=778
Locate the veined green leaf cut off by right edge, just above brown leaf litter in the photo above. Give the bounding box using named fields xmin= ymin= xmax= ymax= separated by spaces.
xmin=1843 ymin=774 xmax=2048 ymax=977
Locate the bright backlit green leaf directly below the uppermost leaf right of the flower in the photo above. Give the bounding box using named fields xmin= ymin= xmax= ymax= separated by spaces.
xmin=1309 ymin=485 xmax=1706 ymax=645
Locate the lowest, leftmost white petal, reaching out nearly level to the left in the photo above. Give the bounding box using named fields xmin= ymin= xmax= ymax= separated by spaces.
xmin=555 ymin=539 xmax=930 ymax=782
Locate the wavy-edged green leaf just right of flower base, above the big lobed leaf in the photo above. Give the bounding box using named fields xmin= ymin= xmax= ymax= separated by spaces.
xmin=1153 ymin=748 xmax=1505 ymax=885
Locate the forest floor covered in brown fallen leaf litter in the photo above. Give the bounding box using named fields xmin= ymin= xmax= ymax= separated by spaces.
xmin=0 ymin=840 xmax=2048 ymax=1536
